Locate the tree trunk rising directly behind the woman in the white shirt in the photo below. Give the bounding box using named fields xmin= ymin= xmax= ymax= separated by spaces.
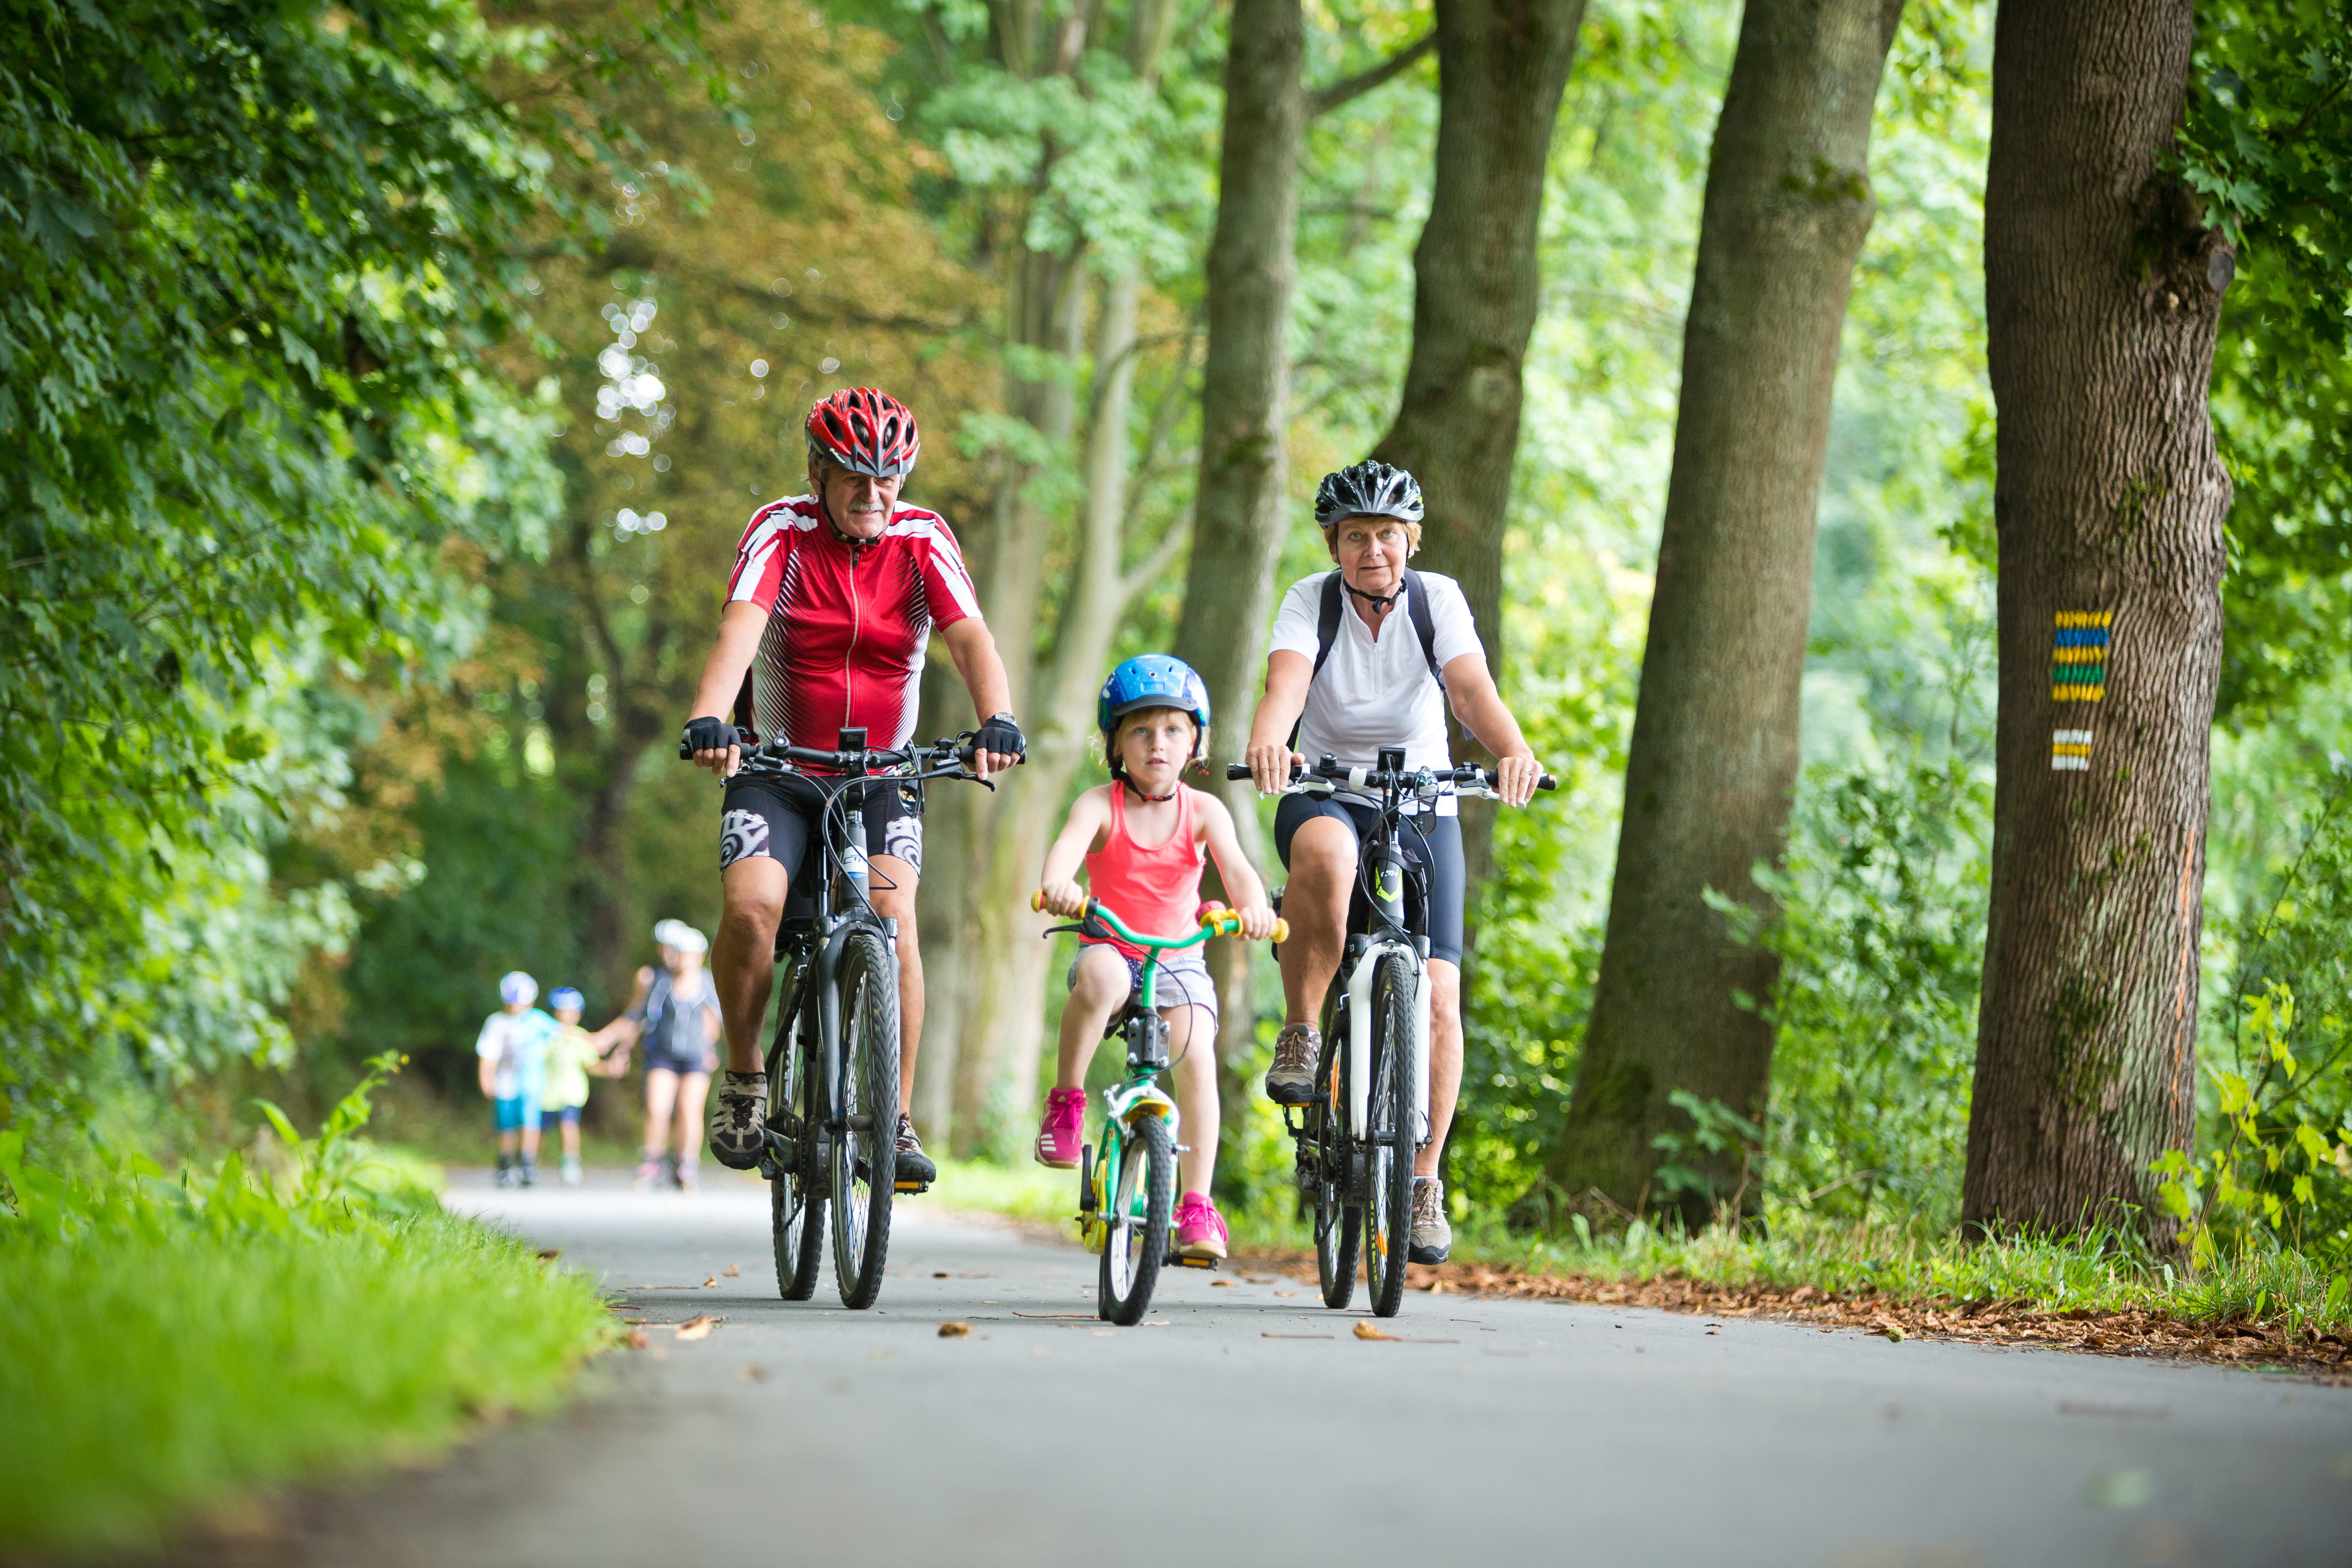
xmin=1374 ymin=0 xmax=1585 ymax=907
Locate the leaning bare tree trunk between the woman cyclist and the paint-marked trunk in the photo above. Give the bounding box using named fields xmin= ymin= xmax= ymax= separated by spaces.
xmin=1548 ymin=0 xmax=1903 ymax=1225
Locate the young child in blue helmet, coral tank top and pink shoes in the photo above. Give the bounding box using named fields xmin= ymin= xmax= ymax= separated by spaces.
xmin=1037 ymin=653 xmax=1275 ymax=1260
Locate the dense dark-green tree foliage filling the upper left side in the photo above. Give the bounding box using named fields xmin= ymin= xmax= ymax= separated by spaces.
xmin=0 ymin=0 xmax=694 ymax=1131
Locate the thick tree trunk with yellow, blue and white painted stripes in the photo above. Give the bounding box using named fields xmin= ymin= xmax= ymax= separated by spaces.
xmin=1962 ymin=0 xmax=2234 ymax=1232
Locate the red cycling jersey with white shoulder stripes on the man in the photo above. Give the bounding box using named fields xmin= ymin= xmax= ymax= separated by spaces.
xmin=727 ymin=496 xmax=981 ymax=750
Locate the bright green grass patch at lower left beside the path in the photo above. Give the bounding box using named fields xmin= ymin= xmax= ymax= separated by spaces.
xmin=0 ymin=1058 xmax=612 ymax=1549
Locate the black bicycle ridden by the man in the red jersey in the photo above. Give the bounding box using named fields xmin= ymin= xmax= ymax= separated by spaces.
xmin=680 ymin=729 xmax=995 ymax=1307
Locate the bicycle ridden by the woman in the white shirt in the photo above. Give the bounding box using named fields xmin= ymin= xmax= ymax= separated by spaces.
xmin=1225 ymin=745 xmax=1555 ymax=1317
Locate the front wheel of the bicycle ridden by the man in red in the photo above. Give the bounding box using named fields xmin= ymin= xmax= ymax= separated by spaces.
xmin=833 ymin=928 xmax=898 ymax=1309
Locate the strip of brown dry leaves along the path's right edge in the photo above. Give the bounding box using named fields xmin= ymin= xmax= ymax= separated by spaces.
xmin=1249 ymin=1253 xmax=2352 ymax=1384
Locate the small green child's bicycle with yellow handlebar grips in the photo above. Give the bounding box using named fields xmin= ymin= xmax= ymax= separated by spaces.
xmin=1030 ymin=891 xmax=1289 ymax=1328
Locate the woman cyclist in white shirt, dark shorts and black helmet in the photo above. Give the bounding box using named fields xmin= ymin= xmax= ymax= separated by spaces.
xmin=1249 ymin=461 xmax=1543 ymax=1262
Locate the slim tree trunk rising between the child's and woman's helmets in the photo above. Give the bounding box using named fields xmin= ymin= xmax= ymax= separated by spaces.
xmin=1176 ymin=0 xmax=1305 ymax=1164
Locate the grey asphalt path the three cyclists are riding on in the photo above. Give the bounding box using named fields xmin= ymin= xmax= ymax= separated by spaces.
xmin=234 ymin=1173 xmax=2352 ymax=1568
